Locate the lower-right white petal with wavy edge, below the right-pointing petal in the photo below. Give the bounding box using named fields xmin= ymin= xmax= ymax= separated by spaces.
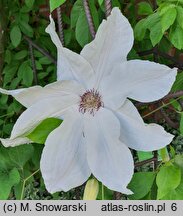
xmin=116 ymin=100 xmax=174 ymax=151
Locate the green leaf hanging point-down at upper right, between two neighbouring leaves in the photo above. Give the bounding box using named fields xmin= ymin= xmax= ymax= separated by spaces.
xmin=150 ymin=22 xmax=163 ymax=47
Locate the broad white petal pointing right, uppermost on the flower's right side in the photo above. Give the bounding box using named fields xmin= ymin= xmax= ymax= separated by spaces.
xmin=100 ymin=60 xmax=177 ymax=108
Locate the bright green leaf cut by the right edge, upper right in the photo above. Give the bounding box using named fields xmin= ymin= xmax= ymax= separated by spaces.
xmin=169 ymin=24 xmax=183 ymax=50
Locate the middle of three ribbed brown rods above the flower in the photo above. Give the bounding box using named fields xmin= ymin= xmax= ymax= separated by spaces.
xmin=83 ymin=0 xmax=96 ymax=39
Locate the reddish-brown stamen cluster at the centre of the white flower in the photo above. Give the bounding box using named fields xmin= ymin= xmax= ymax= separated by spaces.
xmin=79 ymin=89 xmax=104 ymax=115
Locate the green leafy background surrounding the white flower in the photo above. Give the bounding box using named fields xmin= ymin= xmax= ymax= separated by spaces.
xmin=0 ymin=0 xmax=183 ymax=199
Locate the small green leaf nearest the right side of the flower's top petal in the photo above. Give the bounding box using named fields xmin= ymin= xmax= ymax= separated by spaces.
xmin=134 ymin=19 xmax=147 ymax=41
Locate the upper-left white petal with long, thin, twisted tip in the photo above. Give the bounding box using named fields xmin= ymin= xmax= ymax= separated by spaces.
xmin=46 ymin=16 xmax=94 ymax=87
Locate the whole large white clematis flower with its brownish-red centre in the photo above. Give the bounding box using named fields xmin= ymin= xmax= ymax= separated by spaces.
xmin=1 ymin=8 xmax=177 ymax=194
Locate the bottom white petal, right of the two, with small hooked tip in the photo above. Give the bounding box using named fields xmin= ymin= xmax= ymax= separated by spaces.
xmin=84 ymin=108 xmax=134 ymax=194
